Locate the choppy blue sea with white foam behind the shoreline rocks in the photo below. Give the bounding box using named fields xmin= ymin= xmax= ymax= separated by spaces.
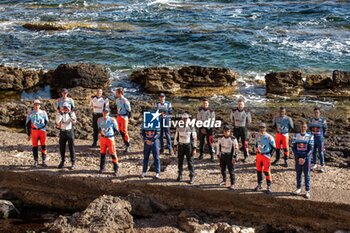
xmin=0 ymin=0 xmax=350 ymax=101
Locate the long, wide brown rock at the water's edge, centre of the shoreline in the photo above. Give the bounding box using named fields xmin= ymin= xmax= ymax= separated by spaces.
xmin=130 ymin=66 xmax=237 ymax=95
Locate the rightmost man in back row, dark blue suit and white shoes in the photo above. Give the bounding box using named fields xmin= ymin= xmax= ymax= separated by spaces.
xmin=309 ymin=107 xmax=327 ymax=172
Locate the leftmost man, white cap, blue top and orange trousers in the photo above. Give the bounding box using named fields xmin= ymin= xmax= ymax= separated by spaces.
xmin=26 ymin=99 xmax=49 ymax=167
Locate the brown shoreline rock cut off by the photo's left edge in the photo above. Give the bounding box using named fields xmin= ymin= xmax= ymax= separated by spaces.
xmin=0 ymin=65 xmax=43 ymax=91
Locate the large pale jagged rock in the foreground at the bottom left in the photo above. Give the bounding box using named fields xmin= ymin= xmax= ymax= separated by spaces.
xmin=47 ymin=195 xmax=134 ymax=233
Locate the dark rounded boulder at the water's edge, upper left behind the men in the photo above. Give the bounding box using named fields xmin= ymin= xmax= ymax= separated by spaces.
xmin=51 ymin=63 xmax=110 ymax=91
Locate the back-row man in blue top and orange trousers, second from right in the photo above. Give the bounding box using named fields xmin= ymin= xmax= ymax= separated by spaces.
xmin=272 ymin=107 xmax=294 ymax=167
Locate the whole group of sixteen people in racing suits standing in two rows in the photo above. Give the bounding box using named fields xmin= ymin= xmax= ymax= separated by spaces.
xmin=26 ymin=88 xmax=327 ymax=198
